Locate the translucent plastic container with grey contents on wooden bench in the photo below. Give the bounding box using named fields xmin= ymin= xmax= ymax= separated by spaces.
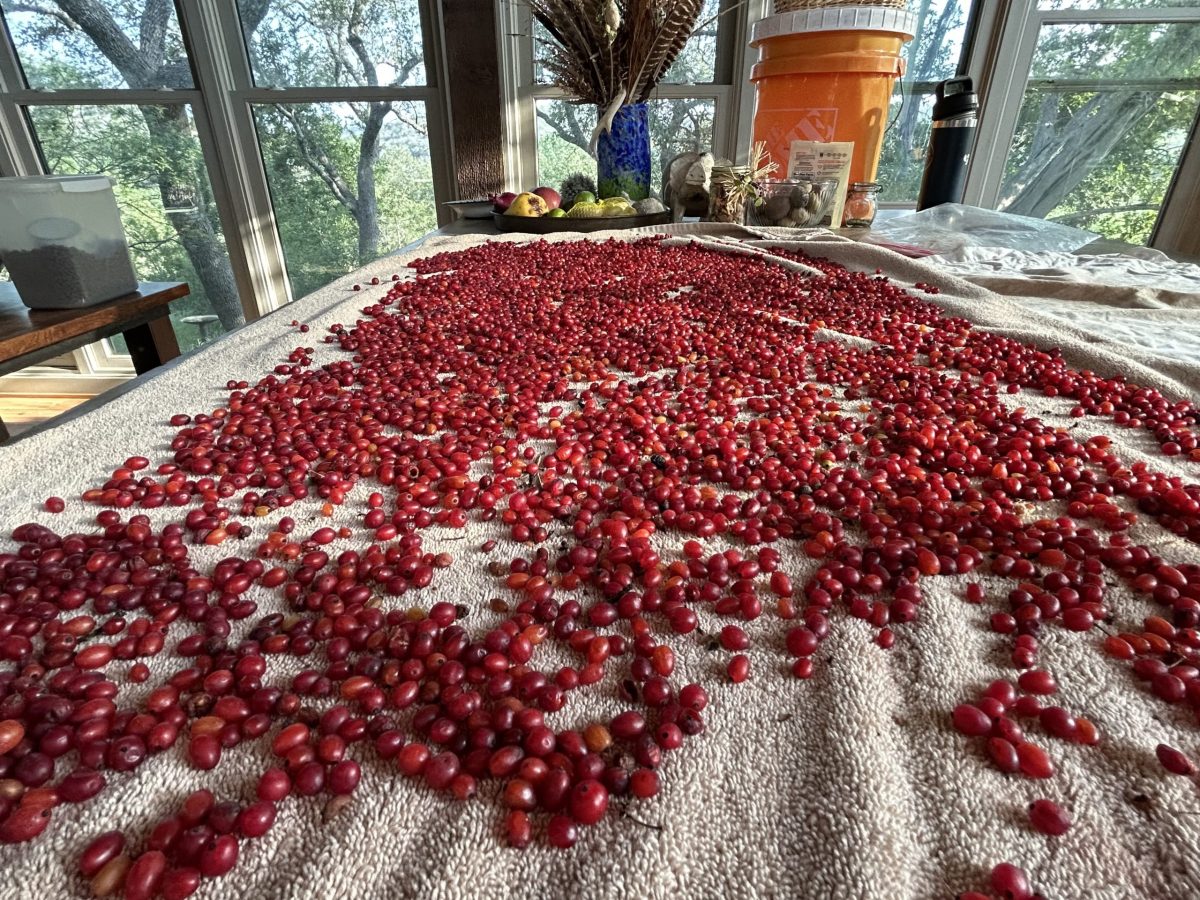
xmin=0 ymin=175 xmax=138 ymax=310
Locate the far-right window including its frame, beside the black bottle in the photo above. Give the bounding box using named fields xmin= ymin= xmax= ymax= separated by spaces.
xmin=968 ymin=0 xmax=1200 ymax=244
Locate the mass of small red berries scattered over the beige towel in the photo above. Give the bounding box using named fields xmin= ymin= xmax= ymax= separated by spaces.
xmin=0 ymin=240 xmax=1200 ymax=898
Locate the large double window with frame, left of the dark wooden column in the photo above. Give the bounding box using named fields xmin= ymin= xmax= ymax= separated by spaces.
xmin=0 ymin=0 xmax=451 ymax=368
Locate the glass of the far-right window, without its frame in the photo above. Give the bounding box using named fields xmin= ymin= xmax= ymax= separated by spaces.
xmin=997 ymin=23 xmax=1200 ymax=244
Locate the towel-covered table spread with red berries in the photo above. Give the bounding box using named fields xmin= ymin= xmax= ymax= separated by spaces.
xmin=0 ymin=227 xmax=1200 ymax=900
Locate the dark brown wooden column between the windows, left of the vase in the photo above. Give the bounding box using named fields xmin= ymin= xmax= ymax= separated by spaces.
xmin=442 ymin=0 xmax=504 ymax=200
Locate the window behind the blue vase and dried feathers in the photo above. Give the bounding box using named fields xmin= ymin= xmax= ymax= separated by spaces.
xmin=502 ymin=0 xmax=744 ymax=193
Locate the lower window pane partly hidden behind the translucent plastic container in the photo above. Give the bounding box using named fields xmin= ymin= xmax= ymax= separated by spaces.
xmin=29 ymin=103 xmax=244 ymax=350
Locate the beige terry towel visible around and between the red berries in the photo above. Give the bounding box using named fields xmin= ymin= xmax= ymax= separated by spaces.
xmin=0 ymin=227 xmax=1200 ymax=900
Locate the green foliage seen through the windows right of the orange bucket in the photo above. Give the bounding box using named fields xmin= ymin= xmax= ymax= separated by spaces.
xmin=878 ymin=0 xmax=1200 ymax=244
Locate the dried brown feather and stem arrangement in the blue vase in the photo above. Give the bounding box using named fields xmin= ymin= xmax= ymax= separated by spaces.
xmin=529 ymin=0 xmax=703 ymax=146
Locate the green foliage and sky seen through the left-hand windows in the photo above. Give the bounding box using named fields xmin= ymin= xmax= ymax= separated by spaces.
xmin=0 ymin=0 xmax=437 ymax=340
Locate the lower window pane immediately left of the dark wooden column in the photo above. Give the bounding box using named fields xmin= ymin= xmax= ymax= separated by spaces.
xmin=254 ymin=102 xmax=437 ymax=298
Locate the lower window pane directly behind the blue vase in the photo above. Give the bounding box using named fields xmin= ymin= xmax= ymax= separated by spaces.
xmin=538 ymin=97 xmax=716 ymax=196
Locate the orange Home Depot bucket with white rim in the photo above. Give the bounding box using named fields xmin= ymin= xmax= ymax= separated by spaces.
xmin=750 ymin=6 xmax=916 ymax=188
